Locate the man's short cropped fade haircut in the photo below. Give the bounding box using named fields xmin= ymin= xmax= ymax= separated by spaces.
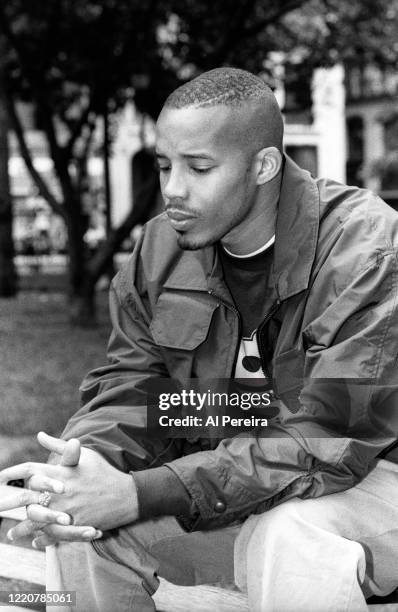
xmin=164 ymin=67 xmax=283 ymax=151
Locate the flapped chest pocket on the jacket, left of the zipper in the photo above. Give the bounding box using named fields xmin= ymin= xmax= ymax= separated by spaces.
xmin=150 ymin=291 xmax=218 ymax=351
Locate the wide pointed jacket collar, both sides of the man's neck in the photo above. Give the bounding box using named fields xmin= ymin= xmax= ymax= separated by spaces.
xmin=164 ymin=157 xmax=319 ymax=300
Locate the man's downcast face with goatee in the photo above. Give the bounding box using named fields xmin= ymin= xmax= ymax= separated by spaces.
xmin=156 ymin=105 xmax=257 ymax=250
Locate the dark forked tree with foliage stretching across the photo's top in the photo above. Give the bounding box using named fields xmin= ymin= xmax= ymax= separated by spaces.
xmin=0 ymin=0 xmax=397 ymax=323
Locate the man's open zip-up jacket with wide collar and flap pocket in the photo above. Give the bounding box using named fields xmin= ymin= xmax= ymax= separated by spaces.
xmin=64 ymin=158 xmax=398 ymax=529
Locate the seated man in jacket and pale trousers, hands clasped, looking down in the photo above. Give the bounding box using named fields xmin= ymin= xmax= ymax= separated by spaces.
xmin=1 ymin=68 xmax=398 ymax=612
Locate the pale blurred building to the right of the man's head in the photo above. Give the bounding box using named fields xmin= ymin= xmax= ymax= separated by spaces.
xmin=283 ymin=64 xmax=398 ymax=213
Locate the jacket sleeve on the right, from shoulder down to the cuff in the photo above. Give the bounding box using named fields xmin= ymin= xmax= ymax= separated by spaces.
xmin=162 ymin=246 xmax=398 ymax=529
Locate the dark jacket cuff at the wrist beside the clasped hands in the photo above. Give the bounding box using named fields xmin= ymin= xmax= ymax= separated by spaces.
xmin=130 ymin=466 xmax=192 ymax=520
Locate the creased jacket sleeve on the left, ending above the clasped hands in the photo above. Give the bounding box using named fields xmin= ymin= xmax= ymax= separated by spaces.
xmin=63 ymin=232 xmax=172 ymax=471
